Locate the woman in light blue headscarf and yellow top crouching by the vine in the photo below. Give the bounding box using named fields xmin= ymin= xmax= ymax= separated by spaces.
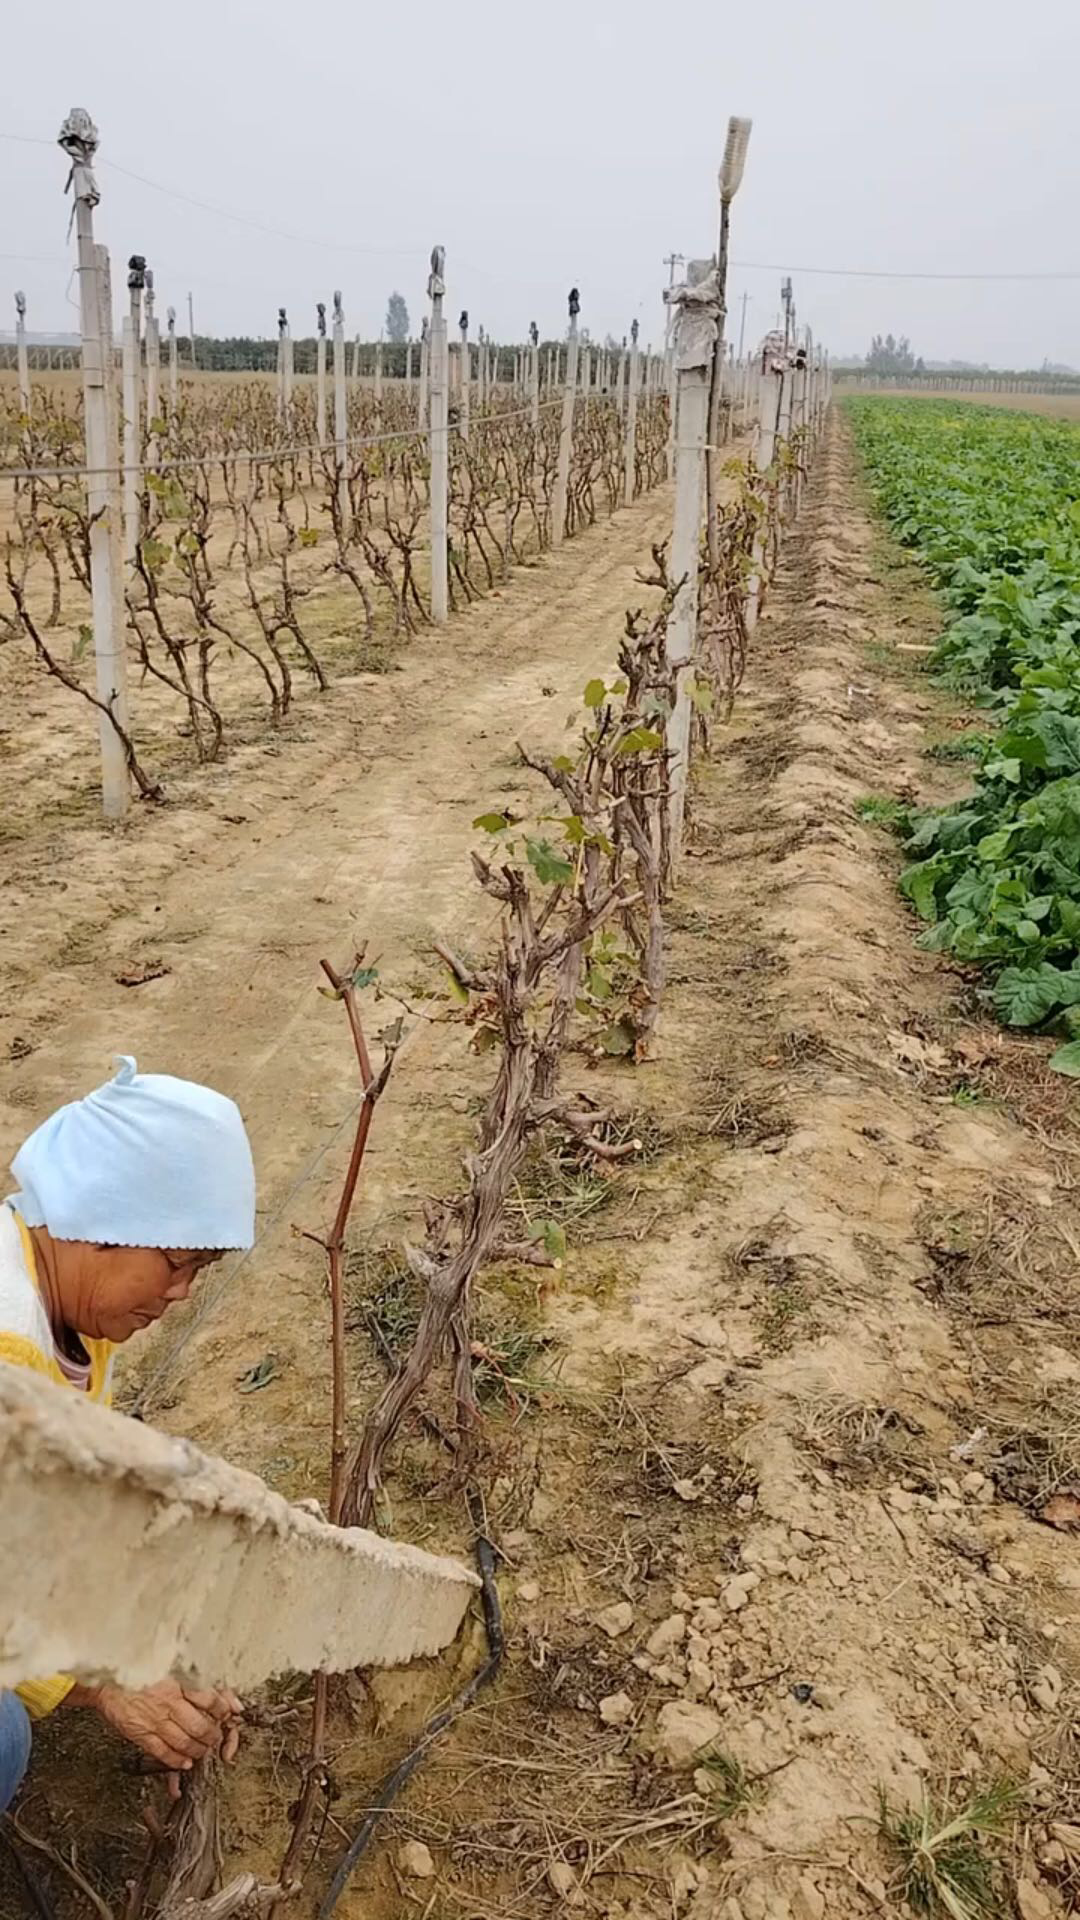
xmin=0 ymin=1056 xmax=256 ymax=1809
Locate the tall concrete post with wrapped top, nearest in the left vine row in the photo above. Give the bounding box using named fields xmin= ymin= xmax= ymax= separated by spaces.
xmin=60 ymin=108 xmax=129 ymax=820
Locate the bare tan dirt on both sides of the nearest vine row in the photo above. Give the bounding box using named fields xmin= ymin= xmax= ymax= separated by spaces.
xmin=0 ymin=420 xmax=1080 ymax=1920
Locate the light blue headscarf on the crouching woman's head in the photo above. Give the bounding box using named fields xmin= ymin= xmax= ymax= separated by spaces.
xmin=12 ymin=1054 xmax=256 ymax=1248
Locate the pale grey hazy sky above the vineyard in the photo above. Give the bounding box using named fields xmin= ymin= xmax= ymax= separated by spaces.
xmin=0 ymin=0 xmax=1080 ymax=365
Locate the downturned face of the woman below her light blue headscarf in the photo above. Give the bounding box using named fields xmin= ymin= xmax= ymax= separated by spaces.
xmin=52 ymin=1240 xmax=221 ymax=1344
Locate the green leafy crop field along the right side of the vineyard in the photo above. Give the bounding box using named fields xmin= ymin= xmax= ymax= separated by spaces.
xmin=846 ymin=399 xmax=1080 ymax=1073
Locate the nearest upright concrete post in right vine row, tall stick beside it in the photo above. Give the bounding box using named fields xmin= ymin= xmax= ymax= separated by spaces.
xmin=667 ymin=261 xmax=721 ymax=872
